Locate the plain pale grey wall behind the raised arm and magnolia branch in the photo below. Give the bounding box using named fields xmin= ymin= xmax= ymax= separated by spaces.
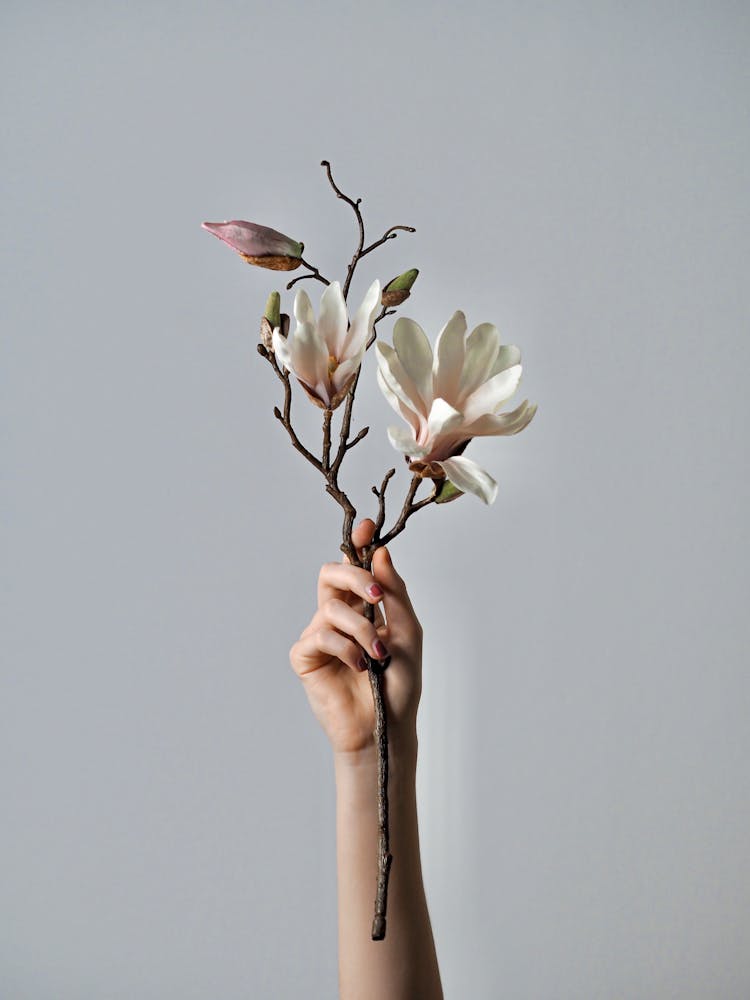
xmin=0 ymin=0 xmax=750 ymax=1000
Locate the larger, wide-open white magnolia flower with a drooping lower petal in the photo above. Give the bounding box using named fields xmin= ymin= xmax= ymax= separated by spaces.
xmin=375 ymin=312 xmax=536 ymax=504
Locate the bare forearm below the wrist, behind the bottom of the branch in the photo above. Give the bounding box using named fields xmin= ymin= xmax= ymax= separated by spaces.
xmin=335 ymin=737 xmax=443 ymax=1000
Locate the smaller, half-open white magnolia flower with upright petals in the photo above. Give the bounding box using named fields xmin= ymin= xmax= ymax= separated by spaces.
xmin=272 ymin=281 xmax=380 ymax=410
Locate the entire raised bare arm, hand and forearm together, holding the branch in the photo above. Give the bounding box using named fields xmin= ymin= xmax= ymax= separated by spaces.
xmin=289 ymin=520 xmax=443 ymax=1000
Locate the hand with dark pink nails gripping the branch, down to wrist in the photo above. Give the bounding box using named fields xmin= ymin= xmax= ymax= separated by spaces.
xmin=289 ymin=520 xmax=422 ymax=753
